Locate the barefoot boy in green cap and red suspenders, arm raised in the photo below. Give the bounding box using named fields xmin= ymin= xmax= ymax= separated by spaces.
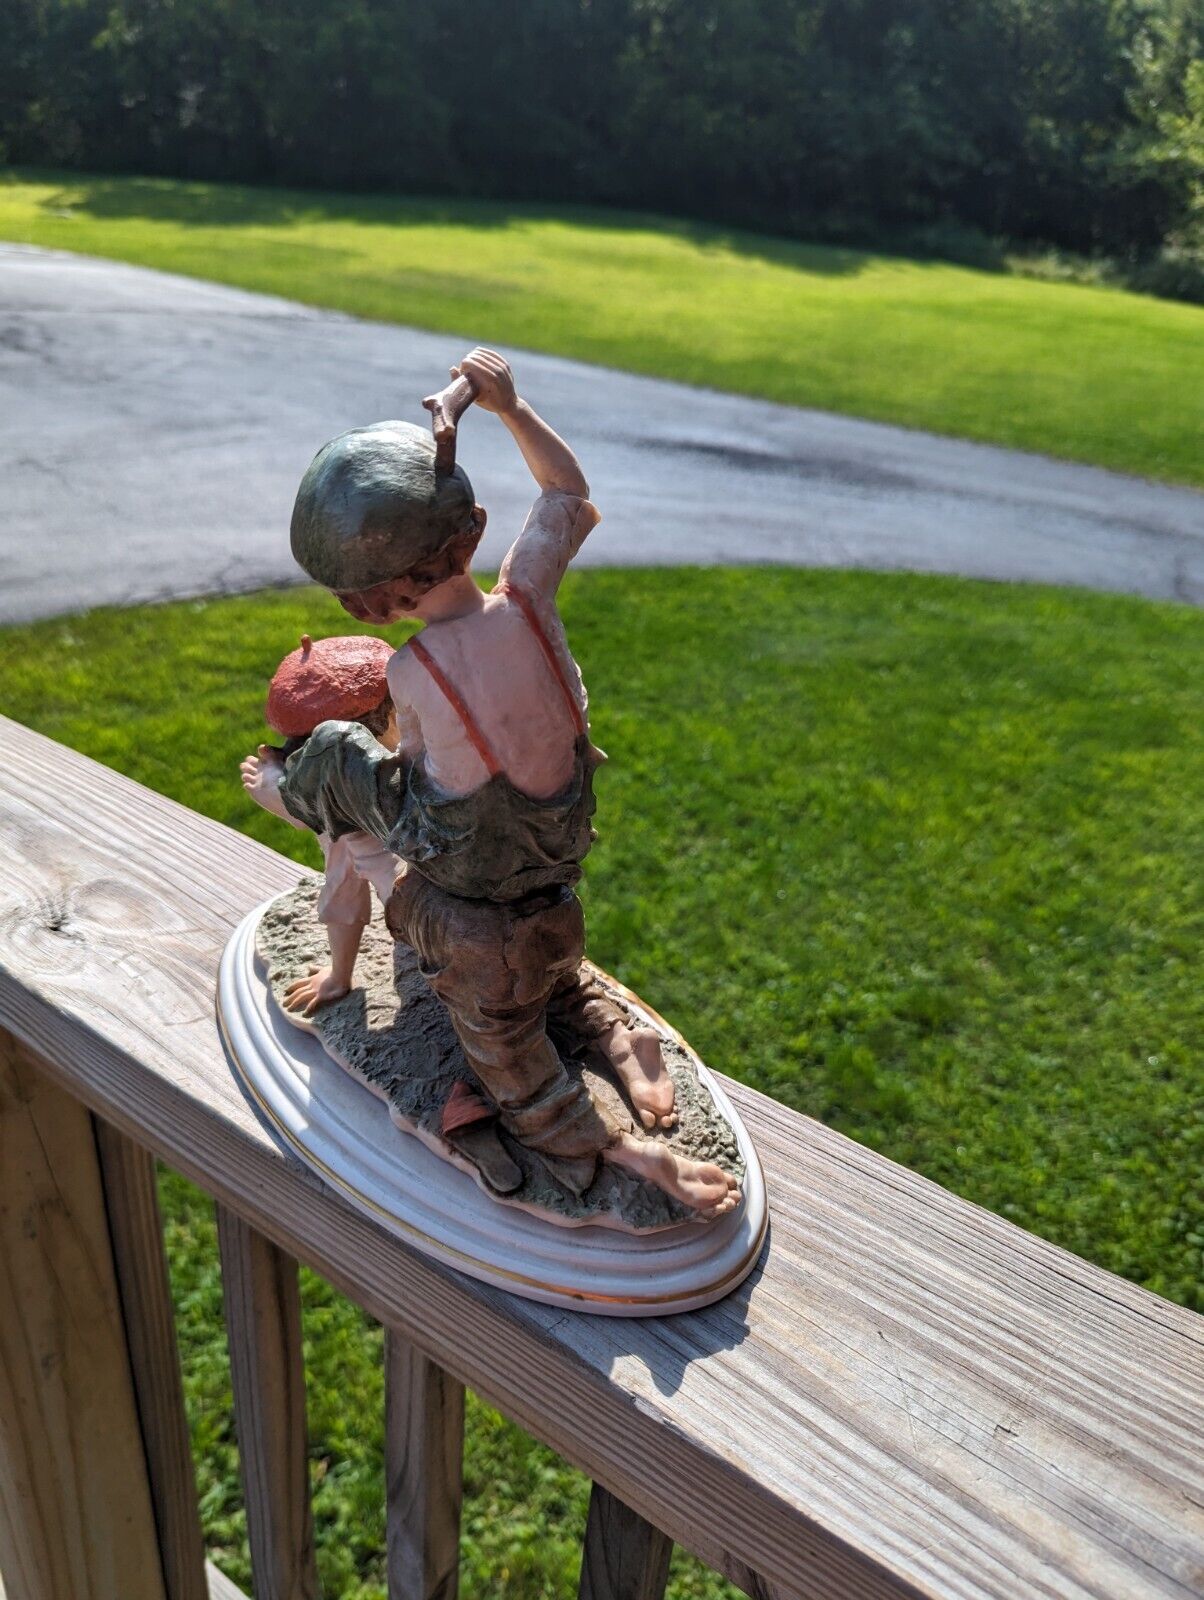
xmin=244 ymin=349 xmax=740 ymax=1218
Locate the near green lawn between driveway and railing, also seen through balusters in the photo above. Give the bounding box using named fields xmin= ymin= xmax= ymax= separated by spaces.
xmin=0 ymin=570 xmax=1204 ymax=1600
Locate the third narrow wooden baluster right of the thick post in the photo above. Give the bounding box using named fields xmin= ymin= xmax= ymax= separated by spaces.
xmin=384 ymin=1328 xmax=464 ymax=1600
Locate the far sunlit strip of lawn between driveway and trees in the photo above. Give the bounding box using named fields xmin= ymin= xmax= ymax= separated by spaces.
xmin=0 ymin=173 xmax=1204 ymax=485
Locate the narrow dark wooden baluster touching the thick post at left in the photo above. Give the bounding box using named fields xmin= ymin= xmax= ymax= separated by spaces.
xmin=96 ymin=1118 xmax=208 ymax=1600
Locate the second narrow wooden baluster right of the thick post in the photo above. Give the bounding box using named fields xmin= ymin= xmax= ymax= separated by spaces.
xmin=218 ymin=1205 xmax=319 ymax=1600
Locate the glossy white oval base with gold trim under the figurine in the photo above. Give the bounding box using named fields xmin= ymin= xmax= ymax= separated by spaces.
xmin=218 ymin=901 xmax=769 ymax=1317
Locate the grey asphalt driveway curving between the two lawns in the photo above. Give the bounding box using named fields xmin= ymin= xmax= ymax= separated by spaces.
xmin=0 ymin=245 xmax=1204 ymax=621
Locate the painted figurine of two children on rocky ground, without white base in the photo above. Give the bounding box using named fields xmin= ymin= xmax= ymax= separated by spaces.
xmin=224 ymin=349 xmax=764 ymax=1312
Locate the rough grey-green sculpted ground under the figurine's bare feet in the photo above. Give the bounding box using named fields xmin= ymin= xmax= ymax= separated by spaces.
xmin=256 ymin=877 xmax=744 ymax=1232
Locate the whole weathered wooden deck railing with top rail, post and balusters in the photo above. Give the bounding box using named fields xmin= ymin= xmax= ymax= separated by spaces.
xmin=0 ymin=720 xmax=1204 ymax=1600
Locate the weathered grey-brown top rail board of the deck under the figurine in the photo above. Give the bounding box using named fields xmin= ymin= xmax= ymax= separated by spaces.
xmin=0 ymin=722 xmax=1204 ymax=1600
